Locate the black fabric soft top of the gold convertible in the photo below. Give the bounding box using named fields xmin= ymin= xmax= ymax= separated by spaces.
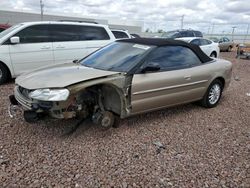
xmin=118 ymin=38 xmax=213 ymax=63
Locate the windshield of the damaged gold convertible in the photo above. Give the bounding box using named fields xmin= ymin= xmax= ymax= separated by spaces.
xmin=80 ymin=42 xmax=152 ymax=72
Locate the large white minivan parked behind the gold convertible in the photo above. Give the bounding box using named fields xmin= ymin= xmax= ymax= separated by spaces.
xmin=0 ymin=21 xmax=115 ymax=84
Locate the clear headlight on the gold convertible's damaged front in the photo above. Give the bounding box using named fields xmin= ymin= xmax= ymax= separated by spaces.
xmin=29 ymin=89 xmax=69 ymax=101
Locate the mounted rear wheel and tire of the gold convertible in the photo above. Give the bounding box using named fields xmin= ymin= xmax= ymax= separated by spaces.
xmin=200 ymin=79 xmax=223 ymax=108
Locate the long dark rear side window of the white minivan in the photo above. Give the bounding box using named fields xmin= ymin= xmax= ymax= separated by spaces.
xmin=50 ymin=25 xmax=110 ymax=42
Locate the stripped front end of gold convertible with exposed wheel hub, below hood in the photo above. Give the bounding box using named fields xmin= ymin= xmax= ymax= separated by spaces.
xmin=10 ymin=74 xmax=132 ymax=127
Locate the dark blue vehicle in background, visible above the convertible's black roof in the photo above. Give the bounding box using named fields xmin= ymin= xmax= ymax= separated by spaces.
xmin=161 ymin=29 xmax=203 ymax=38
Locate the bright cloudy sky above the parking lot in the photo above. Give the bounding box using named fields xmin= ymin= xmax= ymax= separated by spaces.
xmin=0 ymin=0 xmax=250 ymax=32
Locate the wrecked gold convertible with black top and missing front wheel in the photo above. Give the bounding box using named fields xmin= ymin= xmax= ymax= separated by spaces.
xmin=10 ymin=38 xmax=232 ymax=127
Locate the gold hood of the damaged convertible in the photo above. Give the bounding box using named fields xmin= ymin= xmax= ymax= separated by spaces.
xmin=16 ymin=63 xmax=119 ymax=90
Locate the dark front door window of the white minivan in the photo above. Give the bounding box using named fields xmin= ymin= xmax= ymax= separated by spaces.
xmin=14 ymin=25 xmax=51 ymax=43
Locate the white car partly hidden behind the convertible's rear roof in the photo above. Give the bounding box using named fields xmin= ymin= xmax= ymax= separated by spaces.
xmin=178 ymin=37 xmax=220 ymax=57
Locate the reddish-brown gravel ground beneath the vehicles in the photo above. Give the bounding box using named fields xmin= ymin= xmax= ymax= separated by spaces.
xmin=0 ymin=52 xmax=250 ymax=187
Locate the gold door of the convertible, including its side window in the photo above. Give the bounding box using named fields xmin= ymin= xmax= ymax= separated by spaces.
xmin=131 ymin=46 xmax=211 ymax=114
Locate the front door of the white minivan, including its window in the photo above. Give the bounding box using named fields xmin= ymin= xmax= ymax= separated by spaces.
xmin=6 ymin=24 xmax=54 ymax=76
